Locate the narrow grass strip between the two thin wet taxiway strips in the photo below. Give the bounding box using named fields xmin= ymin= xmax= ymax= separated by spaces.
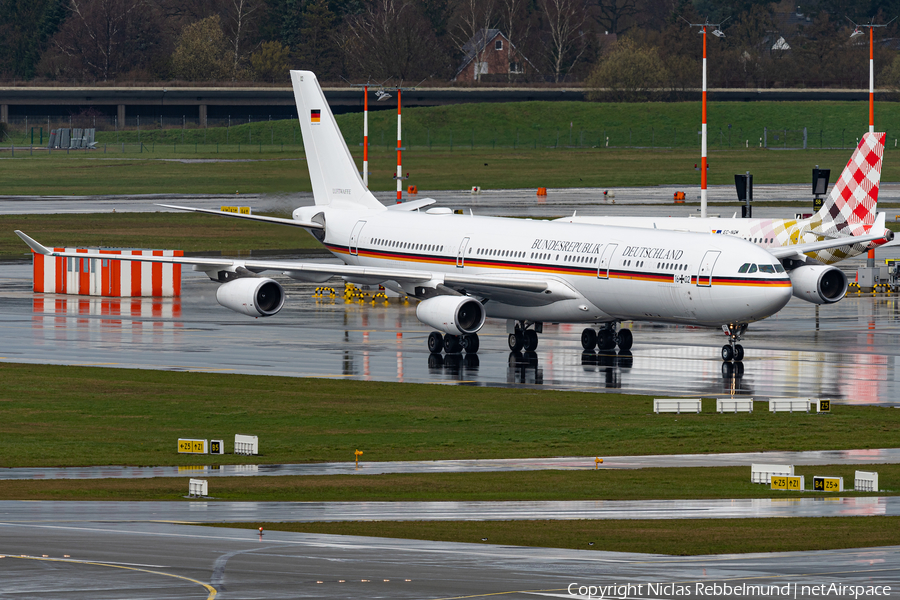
xmin=0 ymin=464 xmax=900 ymax=502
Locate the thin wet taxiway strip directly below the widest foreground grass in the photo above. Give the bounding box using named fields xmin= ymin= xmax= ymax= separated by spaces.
xmin=0 ymin=448 xmax=900 ymax=480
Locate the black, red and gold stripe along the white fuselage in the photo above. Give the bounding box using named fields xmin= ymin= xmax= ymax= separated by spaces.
xmin=325 ymin=244 xmax=791 ymax=287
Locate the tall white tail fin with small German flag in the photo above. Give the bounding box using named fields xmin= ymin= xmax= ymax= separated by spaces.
xmin=291 ymin=71 xmax=386 ymax=210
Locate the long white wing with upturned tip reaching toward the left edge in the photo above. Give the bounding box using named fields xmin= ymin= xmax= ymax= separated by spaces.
xmin=15 ymin=230 xmax=564 ymax=303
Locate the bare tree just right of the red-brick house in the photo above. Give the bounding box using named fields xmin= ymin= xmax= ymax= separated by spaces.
xmin=539 ymin=0 xmax=587 ymax=83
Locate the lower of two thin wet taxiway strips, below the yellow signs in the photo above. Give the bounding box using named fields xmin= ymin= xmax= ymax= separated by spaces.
xmin=0 ymin=496 xmax=900 ymax=525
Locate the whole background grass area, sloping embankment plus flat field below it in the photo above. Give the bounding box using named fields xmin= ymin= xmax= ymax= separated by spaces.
xmin=0 ymin=102 xmax=900 ymax=195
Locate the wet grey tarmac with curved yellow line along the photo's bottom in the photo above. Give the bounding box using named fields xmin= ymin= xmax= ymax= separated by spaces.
xmin=0 ymin=518 xmax=900 ymax=600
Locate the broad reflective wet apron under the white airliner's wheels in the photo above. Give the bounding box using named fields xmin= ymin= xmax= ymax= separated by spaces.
xmin=0 ymin=260 xmax=900 ymax=406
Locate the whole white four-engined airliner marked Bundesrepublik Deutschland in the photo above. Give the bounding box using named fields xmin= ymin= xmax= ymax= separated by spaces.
xmin=16 ymin=71 xmax=892 ymax=360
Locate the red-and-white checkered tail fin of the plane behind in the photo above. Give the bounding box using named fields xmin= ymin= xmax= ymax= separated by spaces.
xmin=816 ymin=133 xmax=885 ymax=235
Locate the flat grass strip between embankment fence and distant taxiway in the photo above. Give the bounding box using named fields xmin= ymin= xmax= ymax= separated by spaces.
xmin=0 ymin=148 xmax=900 ymax=195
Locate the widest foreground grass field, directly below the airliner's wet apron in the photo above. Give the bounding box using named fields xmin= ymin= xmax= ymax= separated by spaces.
xmin=0 ymin=363 xmax=900 ymax=467
